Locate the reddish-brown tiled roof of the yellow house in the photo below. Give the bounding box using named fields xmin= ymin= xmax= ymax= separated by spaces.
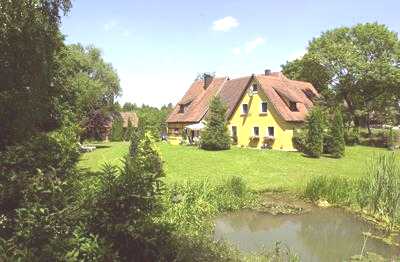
xmin=167 ymin=72 xmax=318 ymax=123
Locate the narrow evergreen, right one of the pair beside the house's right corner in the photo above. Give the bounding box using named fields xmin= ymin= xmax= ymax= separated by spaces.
xmin=330 ymin=110 xmax=345 ymax=158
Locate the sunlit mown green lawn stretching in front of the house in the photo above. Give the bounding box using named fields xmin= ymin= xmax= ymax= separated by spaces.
xmin=80 ymin=142 xmax=398 ymax=190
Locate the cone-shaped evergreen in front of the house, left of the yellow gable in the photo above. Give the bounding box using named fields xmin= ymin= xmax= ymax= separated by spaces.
xmin=200 ymin=97 xmax=231 ymax=150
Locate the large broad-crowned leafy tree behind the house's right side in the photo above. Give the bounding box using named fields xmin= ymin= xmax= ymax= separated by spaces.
xmin=283 ymin=23 xmax=400 ymax=126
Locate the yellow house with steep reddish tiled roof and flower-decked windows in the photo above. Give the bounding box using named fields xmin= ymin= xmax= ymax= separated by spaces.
xmin=167 ymin=70 xmax=318 ymax=150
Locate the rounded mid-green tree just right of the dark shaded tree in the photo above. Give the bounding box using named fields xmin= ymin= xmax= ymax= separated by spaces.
xmin=58 ymin=44 xmax=121 ymax=124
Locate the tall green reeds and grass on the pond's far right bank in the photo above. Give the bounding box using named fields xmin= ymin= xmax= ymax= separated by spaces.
xmin=304 ymin=153 xmax=400 ymax=227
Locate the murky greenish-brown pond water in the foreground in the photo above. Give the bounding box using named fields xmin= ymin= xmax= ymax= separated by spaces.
xmin=214 ymin=208 xmax=400 ymax=261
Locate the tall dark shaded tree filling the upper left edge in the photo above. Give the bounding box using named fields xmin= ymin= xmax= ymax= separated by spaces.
xmin=0 ymin=0 xmax=71 ymax=150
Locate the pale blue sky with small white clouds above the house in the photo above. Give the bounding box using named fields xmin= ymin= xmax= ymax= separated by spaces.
xmin=62 ymin=0 xmax=400 ymax=106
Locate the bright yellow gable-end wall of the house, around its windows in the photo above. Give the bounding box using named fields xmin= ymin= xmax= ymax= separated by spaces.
xmin=228 ymin=79 xmax=301 ymax=150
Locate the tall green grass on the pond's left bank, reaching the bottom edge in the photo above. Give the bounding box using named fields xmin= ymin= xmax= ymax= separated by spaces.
xmin=155 ymin=177 xmax=256 ymax=261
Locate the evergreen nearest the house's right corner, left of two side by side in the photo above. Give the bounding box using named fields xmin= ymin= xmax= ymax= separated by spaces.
xmin=306 ymin=107 xmax=324 ymax=158
